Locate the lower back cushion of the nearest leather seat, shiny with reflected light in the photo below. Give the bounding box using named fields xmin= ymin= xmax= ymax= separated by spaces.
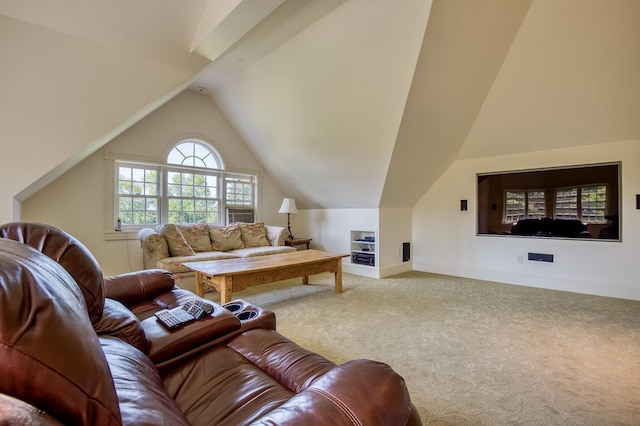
xmin=100 ymin=337 xmax=190 ymax=426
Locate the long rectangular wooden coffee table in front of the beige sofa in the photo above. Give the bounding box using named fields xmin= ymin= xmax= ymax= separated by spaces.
xmin=184 ymin=250 xmax=349 ymax=304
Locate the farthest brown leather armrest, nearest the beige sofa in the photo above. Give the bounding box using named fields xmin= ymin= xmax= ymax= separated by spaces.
xmin=104 ymin=269 xmax=175 ymax=307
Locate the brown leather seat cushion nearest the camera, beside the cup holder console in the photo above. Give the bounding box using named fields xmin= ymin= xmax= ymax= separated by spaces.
xmin=164 ymin=329 xmax=336 ymax=426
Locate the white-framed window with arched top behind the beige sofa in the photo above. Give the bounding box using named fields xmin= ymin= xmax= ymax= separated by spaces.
xmin=114 ymin=138 xmax=257 ymax=230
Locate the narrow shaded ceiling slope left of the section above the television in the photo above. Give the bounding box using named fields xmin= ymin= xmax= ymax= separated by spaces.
xmin=380 ymin=0 xmax=531 ymax=207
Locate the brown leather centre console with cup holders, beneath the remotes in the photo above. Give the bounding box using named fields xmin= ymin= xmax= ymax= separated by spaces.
xmin=141 ymin=302 xmax=241 ymax=364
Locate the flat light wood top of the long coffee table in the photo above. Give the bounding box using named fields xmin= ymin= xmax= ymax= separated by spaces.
xmin=183 ymin=250 xmax=349 ymax=276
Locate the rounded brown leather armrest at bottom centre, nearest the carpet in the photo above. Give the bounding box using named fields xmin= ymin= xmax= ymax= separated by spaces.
xmin=253 ymin=359 xmax=422 ymax=426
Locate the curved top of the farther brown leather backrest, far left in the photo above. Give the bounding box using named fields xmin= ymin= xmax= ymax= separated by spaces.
xmin=0 ymin=222 xmax=104 ymax=323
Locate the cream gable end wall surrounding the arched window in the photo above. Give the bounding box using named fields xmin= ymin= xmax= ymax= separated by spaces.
xmin=22 ymin=91 xmax=286 ymax=275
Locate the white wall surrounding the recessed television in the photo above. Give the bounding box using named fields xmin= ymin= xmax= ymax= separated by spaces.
xmin=413 ymin=140 xmax=640 ymax=300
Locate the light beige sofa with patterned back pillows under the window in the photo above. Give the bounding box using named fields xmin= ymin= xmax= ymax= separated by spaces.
xmin=138 ymin=222 xmax=295 ymax=291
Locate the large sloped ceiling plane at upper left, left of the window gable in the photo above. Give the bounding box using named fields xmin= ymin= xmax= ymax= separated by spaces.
xmin=0 ymin=15 xmax=198 ymax=223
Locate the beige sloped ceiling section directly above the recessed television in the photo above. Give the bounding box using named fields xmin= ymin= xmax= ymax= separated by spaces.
xmin=458 ymin=0 xmax=640 ymax=159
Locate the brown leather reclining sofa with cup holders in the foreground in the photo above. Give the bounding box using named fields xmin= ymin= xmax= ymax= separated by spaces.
xmin=0 ymin=222 xmax=421 ymax=426
